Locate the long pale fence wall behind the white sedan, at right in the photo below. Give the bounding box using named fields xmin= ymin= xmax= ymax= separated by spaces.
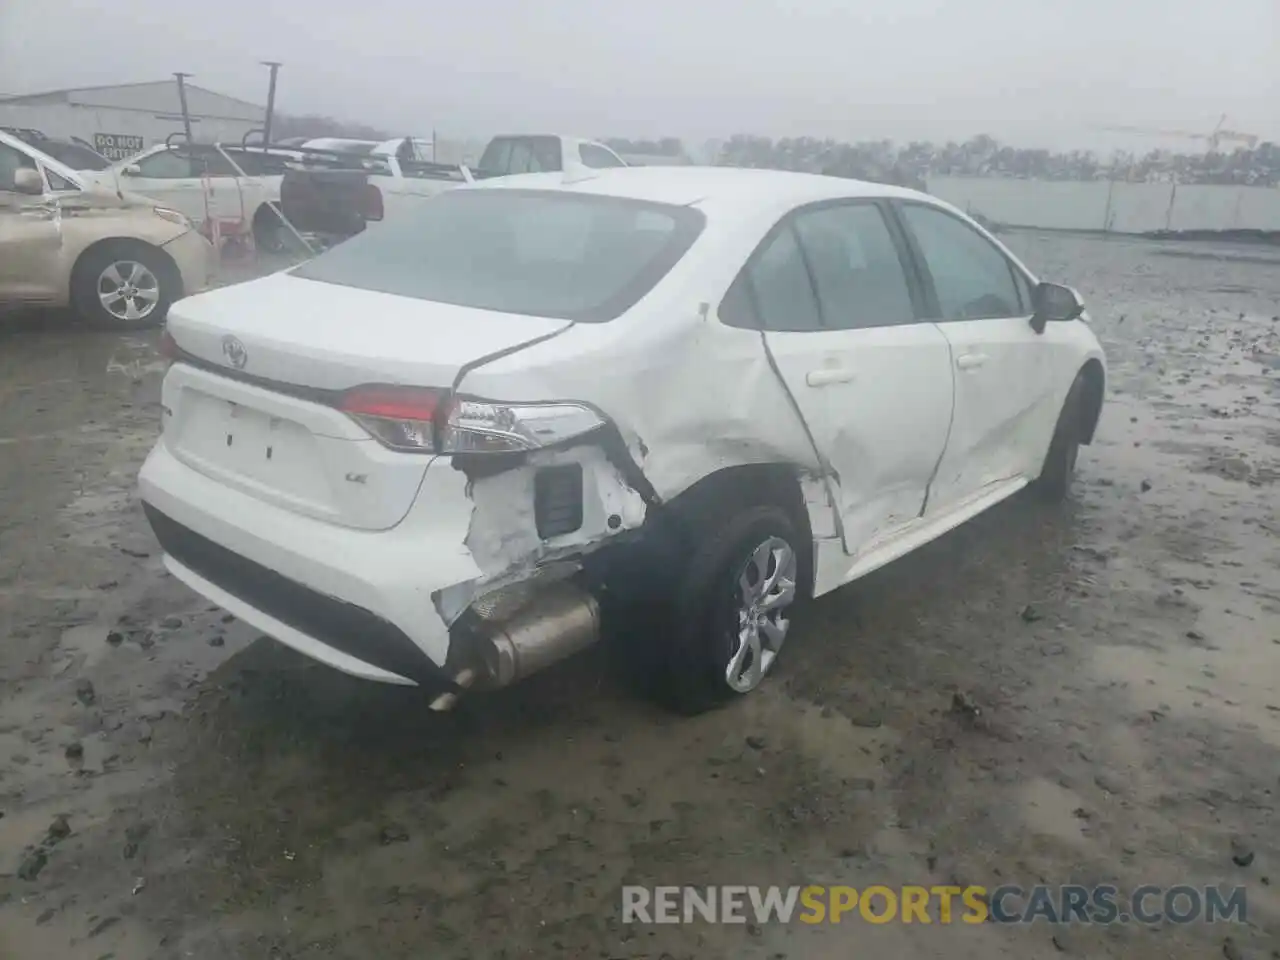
xmin=928 ymin=177 xmax=1280 ymax=233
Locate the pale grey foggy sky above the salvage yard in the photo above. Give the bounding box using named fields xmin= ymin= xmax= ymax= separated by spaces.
xmin=0 ymin=0 xmax=1280 ymax=150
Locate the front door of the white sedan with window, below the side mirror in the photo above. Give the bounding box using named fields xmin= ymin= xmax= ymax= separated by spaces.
xmin=895 ymin=201 xmax=1066 ymax=513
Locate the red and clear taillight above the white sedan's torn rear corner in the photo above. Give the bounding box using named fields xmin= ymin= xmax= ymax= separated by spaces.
xmin=338 ymin=384 xmax=604 ymax=453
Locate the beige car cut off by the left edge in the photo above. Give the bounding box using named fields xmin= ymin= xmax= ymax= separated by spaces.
xmin=0 ymin=131 xmax=216 ymax=329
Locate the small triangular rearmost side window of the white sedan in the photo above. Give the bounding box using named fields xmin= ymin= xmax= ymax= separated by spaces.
xmin=721 ymin=225 xmax=822 ymax=332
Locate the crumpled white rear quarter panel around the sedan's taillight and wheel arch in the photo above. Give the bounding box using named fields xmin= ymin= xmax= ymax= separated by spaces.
xmin=438 ymin=212 xmax=835 ymax=622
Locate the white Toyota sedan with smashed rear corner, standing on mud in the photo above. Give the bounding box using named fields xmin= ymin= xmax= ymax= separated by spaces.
xmin=141 ymin=168 xmax=1106 ymax=709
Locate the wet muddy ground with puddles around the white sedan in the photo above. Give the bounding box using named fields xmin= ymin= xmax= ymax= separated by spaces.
xmin=0 ymin=233 xmax=1280 ymax=960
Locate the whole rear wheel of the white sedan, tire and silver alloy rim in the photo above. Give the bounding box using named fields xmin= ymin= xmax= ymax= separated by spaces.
xmin=663 ymin=506 xmax=806 ymax=713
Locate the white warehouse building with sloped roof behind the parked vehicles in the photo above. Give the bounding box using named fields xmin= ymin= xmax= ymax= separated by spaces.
xmin=0 ymin=79 xmax=266 ymax=160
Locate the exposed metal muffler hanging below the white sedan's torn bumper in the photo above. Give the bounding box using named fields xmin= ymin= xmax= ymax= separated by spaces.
xmin=475 ymin=580 xmax=600 ymax=687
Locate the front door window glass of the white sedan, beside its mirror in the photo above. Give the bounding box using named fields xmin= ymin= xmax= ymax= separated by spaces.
xmin=899 ymin=204 xmax=1030 ymax=320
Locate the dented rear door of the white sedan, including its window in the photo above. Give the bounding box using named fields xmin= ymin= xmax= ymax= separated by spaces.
xmin=722 ymin=201 xmax=951 ymax=556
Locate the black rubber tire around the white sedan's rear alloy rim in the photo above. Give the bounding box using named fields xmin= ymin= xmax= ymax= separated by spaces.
xmin=659 ymin=506 xmax=812 ymax=714
